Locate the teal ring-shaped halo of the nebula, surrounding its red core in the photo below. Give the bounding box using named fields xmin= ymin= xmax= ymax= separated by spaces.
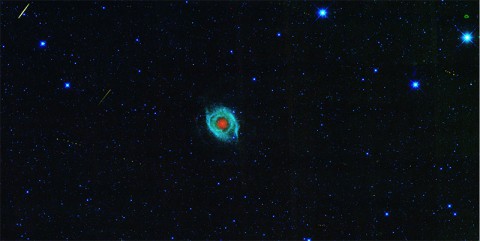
xmin=206 ymin=107 xmax=240 ymax=142
